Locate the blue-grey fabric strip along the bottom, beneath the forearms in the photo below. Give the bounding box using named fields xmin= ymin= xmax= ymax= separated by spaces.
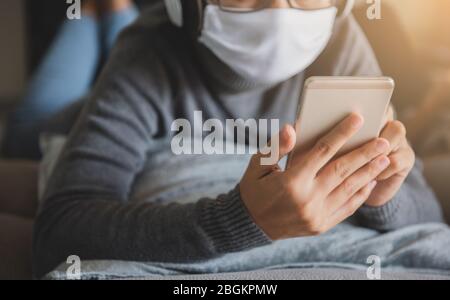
xmin=47 ymin=224 xmax=450 ymax=279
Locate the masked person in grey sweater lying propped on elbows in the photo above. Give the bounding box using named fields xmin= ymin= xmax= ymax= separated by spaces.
xmin=33 ymin=0 xmax=450 ymax=277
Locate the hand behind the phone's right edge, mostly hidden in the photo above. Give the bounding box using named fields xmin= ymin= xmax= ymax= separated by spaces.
xmin=366 ymin=109 xmax=416 ymax=207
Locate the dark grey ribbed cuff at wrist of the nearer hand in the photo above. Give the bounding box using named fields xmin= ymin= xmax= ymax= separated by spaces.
xmin=199 ymin=187 xmax=272 ymax=253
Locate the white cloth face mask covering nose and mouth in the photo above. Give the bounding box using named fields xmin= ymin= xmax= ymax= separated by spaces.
xmin=199 ymin=5 xmax=337 ymax=85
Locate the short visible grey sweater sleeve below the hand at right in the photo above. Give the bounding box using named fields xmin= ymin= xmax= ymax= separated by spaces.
xmin=356 ymin=161 xmax=444 ymax=231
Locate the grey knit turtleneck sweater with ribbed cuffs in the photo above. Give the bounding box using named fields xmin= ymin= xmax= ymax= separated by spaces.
xmin=33 ymin=6 xmax=441 ymax=277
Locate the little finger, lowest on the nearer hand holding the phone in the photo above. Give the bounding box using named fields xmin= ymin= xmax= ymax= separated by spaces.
xmin=327 ymin=181 xmax=377 ymax=228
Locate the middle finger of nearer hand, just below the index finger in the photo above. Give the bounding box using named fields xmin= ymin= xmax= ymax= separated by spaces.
xmin=317 ymin=139 xmax=390 ymax=193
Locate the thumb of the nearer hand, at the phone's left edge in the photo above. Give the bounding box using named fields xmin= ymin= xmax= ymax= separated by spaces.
xmin=248 ymin=125 xmax=296 ymax=178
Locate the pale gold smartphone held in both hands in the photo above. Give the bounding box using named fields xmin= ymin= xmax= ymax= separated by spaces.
xmin=287 ymin=77 xmax=395 ymax=167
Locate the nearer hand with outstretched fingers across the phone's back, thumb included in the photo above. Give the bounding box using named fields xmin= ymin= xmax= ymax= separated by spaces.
xmin=240 ymin=114 xmax=390 ymax=240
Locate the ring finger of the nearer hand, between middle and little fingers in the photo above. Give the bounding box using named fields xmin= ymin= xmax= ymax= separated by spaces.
xmin=327 ymin=155 xmax=390 ymax=212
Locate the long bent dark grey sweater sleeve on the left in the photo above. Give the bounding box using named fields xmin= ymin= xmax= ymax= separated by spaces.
xmin=33 ymin=54 xmax=270 ymax=277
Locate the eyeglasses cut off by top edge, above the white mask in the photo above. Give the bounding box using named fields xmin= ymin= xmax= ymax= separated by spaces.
xmin=207 ymin=0 xmax=338 ymax=13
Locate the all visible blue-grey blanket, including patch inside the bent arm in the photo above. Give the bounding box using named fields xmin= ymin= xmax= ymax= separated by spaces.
xmin=41 ymin=140 xmax=450 ymax=279
